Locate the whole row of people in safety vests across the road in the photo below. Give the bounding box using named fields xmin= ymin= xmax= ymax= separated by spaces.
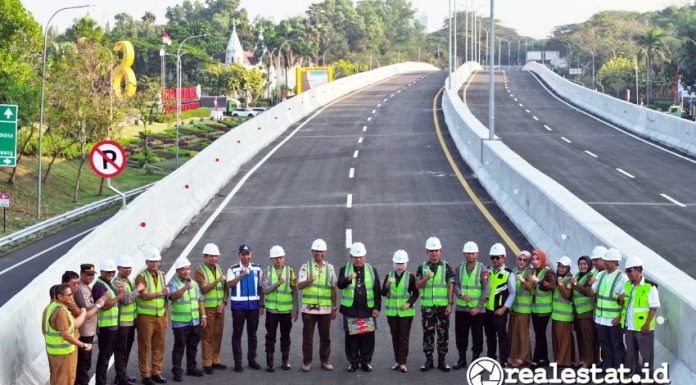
xmin=42 ymin=237 xmax=659 ymax=385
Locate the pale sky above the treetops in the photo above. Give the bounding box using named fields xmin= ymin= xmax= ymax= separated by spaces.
xmin=22 ymin=0 xmax=690 ymax=39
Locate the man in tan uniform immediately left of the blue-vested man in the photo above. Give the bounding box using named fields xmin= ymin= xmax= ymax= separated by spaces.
xmin=193 ymin=243 xmax=230 ymax=374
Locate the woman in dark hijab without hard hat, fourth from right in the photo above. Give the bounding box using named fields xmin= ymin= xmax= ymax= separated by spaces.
xmin=570 ymin=255 xmax=599 ymax=368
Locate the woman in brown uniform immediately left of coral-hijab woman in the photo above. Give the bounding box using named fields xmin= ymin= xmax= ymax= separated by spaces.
xmin=508 ymin=250 xmax=534 ymax=368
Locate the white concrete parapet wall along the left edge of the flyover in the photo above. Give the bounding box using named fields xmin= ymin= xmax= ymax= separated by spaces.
xmin=0 ymin=63 xmax=437 ymax=385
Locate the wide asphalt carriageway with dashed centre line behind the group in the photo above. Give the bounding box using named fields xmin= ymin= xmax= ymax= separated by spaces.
xmin=109 ymin=72 xmax=532 ymax=385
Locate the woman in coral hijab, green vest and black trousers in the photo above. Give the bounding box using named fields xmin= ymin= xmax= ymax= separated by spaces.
xmin=529 ymin=249 xmax=556 ymax=367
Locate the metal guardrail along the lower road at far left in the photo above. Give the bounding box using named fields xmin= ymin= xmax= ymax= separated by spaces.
xmin=0 ymin=182 xmax=156 ymax=248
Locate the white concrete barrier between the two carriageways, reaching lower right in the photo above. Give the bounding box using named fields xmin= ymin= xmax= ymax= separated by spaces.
xmin=442 ymin=63 xmax=696 ymax=378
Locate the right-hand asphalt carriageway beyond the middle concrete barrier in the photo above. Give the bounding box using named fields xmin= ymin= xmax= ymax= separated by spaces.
xmin=465 ymin=68 xmax=696 ymax=277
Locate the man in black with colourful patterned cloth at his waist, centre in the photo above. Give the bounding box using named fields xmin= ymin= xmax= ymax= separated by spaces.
xmin=336 ymin=242 xmax=382 ymax=372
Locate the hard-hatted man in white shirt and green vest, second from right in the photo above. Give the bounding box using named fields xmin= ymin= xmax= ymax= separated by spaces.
xmin=592 ymin=248 xmax=628 ymax=370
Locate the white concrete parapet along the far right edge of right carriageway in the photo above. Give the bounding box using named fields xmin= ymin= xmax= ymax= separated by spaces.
xmin=524 ymin=62 xmax=696 ymax=156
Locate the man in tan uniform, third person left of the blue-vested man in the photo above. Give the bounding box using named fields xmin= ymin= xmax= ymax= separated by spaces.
xmin=135 ymin=246 xmax=169 ymax=385
